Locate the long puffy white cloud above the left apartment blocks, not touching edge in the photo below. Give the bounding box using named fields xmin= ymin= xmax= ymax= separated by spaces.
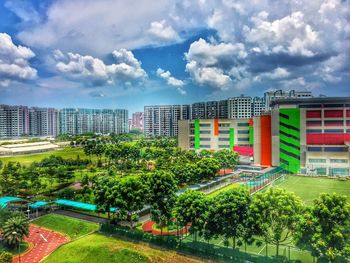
xmin=53 ymin=49 xmax=147 ymax=86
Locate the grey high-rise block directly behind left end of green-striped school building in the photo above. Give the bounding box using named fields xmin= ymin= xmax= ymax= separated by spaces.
xmin=144 ymin=105 xmax=190 ymax=136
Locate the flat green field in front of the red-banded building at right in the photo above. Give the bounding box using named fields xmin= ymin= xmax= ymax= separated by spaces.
xmin=267 ymin=176 xmax=350 ymax=204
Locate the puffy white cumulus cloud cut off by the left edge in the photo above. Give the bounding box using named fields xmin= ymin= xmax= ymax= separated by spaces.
xmin=0 ymin=33 xmax=37 ymax=86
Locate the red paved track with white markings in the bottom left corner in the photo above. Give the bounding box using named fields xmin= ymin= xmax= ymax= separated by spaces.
xmin=12 ymin=225 xmax=69 ymax=263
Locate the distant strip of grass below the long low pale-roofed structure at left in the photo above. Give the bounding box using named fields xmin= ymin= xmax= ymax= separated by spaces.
xmin=0 ymin=147 xmax=87 ymax=165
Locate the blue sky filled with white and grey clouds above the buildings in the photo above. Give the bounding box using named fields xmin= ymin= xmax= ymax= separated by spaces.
xmin=0 ymin=0 xmax=350 ymax=112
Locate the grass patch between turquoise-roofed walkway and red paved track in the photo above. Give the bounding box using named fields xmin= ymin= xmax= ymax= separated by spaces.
xmin=33 ymin=214 xmax=99 ymax=239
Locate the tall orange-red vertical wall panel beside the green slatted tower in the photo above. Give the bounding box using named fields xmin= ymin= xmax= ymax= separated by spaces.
xmin=260 ymin=115 xmax=272 ymax=166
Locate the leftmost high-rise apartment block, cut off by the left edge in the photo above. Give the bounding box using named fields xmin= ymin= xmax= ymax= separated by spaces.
xmin=0 ymin=105 xmax=29 ymax=138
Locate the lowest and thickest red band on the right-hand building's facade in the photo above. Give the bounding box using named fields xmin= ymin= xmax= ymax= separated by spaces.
xmin=306 ymin=133 xmax=350 ymax=145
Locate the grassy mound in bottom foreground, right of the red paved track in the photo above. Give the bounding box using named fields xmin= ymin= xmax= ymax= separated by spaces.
xmin=43 ymin=234 xmax=198 ymax=263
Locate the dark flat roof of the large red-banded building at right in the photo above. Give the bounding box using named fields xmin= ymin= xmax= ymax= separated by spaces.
xmin=270 ymin=97 xmax=350 ymax=106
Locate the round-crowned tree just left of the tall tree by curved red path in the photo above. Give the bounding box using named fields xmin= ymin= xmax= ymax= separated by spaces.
xmin=113 ymin=177 xmax=148 ymax=228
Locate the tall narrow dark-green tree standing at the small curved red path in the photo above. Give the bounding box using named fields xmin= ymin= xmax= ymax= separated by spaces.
xmin=146 ymin=170 xmax=177 ymax=237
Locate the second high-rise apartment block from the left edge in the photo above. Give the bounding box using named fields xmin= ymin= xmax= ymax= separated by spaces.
xmin=29 ymin=107 xmax=58 ymax=137
